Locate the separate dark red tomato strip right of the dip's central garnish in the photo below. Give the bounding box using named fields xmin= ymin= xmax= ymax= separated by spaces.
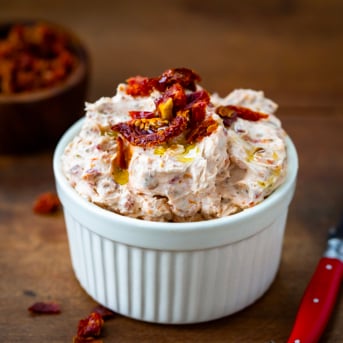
xmin=216 ymin=105 xmax=268 ymax=126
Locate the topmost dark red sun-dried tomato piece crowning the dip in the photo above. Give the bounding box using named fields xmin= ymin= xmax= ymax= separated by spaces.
xmin=156 ymin=68 xmax=201 ymax=91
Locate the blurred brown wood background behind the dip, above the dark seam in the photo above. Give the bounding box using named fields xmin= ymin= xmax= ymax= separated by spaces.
xmin=0 ymin=0 xmax=343 ymax=107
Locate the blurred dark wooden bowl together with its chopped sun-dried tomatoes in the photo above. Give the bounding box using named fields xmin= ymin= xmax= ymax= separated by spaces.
xmin=0 ymin=21 xmax=89 ymax=153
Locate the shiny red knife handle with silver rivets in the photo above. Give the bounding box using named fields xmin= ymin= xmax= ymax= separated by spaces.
xmin=287 ymin=257 xmax=343 ymax=343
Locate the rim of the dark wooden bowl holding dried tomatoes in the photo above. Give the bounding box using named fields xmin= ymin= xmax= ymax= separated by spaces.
xmin=0 ymin=19 xmax=90 ymax=105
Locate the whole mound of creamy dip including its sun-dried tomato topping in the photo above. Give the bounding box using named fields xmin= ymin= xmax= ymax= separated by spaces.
xmin=62 ymin=68 xmax=287 ymax=222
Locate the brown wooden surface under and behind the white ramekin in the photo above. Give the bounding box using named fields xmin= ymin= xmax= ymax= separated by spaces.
xmin=0 ymin=0 xmax=343 ymax=343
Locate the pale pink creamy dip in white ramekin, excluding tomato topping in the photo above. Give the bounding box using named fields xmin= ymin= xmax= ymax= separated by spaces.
xmin=62 ymin=69 xmax=287 ymax=222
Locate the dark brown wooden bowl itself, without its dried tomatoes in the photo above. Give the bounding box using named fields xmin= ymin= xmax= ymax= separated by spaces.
xmin=0 ymin=21 xmax=89 ymax=154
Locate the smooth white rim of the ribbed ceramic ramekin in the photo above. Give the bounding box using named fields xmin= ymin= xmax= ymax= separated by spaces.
xmin=53 ymin=118 xmax=298 ymax=250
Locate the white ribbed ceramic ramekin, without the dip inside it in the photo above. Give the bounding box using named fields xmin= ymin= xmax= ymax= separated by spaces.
xmin=54 ymin=120 xmax=298 ymax=324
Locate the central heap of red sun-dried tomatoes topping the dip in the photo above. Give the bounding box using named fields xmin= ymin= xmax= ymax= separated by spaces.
xmin=112 ymin=68 xmax=217 ymax=147
